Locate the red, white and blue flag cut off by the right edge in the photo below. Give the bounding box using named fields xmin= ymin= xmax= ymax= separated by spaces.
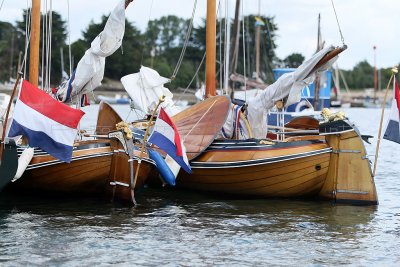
xmin=383 ymin=78 xmax=400 ymax=144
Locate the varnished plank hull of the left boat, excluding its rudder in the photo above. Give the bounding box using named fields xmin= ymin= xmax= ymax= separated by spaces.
xmin=7 ymin=141 xmax=113 ymax=196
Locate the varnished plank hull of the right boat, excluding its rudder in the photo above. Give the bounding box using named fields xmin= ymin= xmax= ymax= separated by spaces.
xmin=177 ymin=141 xmax=331 ymax=198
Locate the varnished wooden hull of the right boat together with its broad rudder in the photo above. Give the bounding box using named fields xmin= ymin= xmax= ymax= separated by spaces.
xmin=176 ymin=121 xmax=378 ymax=205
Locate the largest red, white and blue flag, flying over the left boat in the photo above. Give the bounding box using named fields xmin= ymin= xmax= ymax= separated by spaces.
xmin=8 ymin=80 xmax=85 ymax=162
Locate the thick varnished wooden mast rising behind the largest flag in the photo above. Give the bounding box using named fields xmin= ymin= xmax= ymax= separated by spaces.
xmin=29 ymin=0 xmax=40 ymax=87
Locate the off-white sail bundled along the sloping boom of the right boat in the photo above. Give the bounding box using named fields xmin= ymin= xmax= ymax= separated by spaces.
xmin=248 ymin=46 xmax=337 ymax=138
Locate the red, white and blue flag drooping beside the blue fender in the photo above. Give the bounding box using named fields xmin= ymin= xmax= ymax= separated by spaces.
xmin=148 ymin=108 xmax=192 ymax=173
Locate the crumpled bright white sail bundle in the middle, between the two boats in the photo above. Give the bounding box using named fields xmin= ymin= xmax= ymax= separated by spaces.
xmin=121 ymin=66 xmax=180 ymax=116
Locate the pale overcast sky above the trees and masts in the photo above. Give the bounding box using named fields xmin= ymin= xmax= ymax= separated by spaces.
xmin=0 ymin=0 xmax=400 ymax=69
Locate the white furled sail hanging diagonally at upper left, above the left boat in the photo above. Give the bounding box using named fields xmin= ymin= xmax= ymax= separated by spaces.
xmin=56 ymin=0 xmax=125 ymax=102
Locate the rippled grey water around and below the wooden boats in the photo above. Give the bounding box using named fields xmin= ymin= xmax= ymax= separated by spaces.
xmin=0 ymin=107 xmax=400 ymax=266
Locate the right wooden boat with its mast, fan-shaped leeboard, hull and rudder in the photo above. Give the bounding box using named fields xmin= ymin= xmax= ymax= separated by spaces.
xmin=163 ymin=0 xmax=378 ymax=204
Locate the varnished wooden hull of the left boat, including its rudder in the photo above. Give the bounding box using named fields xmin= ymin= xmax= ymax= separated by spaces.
xmin=6 ymin=140 xmax=154 ymax=203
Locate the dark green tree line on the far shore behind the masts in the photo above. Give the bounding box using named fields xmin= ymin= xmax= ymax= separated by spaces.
xmin=0 ymin=10 xmax=398 ymax=89
